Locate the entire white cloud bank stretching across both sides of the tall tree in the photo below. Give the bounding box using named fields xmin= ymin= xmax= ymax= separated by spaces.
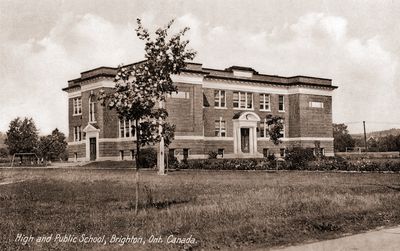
xmin=0 ymin=12 xmax=400 ymax=133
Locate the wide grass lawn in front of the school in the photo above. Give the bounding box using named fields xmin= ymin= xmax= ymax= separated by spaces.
xmin=0 ymin=169 xmax=400 ymax=250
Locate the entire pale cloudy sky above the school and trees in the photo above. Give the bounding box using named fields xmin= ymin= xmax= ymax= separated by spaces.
xmin=0 ymin=0 xmax=400 ymax=134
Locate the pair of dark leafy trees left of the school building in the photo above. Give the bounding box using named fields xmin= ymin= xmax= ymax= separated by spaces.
xmin=0 ymin=117 xmax=68 ymax=161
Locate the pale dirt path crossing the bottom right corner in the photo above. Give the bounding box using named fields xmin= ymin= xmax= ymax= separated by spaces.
xmin=274 ymin=226 xmax=400 ymax=251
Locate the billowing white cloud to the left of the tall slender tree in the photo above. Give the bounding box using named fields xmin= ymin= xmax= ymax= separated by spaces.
xmin=0 ymin=13 xmax=143 ymax=133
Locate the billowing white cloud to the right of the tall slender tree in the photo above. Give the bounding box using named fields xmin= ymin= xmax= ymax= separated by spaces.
xmin=197 ymin=13 xmax=400 ymax=130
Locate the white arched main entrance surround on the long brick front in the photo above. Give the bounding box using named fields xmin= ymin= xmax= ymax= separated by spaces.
xmin=233 ymin=112 xmax=260 ymax=157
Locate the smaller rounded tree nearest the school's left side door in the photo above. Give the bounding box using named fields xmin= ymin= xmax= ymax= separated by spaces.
xmin=38 ymin=128 xmax=67 ymax=160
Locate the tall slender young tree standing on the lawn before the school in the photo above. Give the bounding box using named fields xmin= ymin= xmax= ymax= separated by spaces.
xmin=99 ymin=19 xmax=196 ymax=213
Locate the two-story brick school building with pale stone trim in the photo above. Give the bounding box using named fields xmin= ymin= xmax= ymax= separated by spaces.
xmin=63 ymin=62 xmax=337 ymax=161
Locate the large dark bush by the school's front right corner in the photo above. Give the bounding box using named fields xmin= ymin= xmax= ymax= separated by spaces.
xmin=285 ymin=147 xmax=315 ymax=170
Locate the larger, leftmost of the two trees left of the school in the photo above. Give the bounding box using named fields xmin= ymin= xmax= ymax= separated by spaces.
xmin=4 ymin=117 xmax=38 ymax=154
